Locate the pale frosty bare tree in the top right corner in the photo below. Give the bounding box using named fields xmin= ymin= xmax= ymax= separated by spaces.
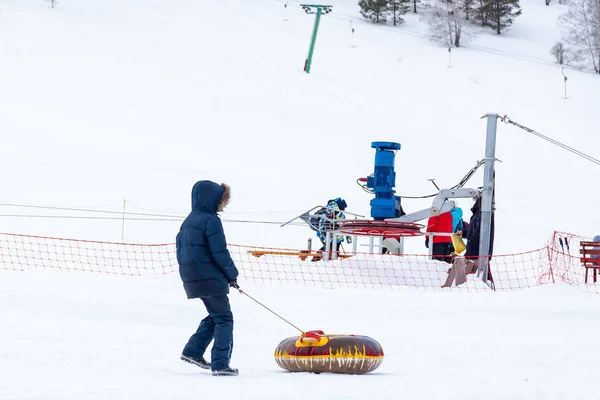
xmin=560 ymin=0 xmax=600 ymax=74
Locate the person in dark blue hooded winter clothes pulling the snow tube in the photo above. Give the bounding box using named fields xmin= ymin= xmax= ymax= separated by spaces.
xmin=176 ymin=181 xmax=239 ymax=375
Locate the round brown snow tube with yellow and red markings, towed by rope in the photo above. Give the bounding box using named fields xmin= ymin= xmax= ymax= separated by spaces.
xmin=275 ymin=331 xmax=383 ymax=374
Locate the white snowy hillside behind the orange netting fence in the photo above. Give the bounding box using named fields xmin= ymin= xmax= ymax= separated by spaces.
xmin=0 ymin=0 xmax=600 ymax=253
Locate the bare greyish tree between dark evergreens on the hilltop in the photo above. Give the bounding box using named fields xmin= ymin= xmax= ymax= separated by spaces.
xmin=427 ymin=0 xmax=469 ymax=48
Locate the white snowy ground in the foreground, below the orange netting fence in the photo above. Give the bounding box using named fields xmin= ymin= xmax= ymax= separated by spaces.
xmin=0 ymin=271 xmax=600 ymax=399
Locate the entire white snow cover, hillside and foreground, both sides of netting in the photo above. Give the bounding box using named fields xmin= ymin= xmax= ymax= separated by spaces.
xmin=0 ymin=0 xmax=600 ymax=399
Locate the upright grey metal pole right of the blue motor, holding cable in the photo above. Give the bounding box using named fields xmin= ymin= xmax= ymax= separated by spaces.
xmin=478 ymin=113 xmax=500 ymax=282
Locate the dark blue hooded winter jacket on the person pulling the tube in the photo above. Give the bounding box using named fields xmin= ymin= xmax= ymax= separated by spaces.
xmin=176 ymin=181 xmax=238 ymax=299
